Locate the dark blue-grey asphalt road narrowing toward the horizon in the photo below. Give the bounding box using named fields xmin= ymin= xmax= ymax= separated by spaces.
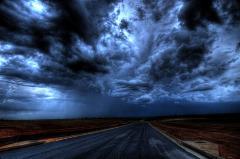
xmin=0 ymin=122 xmax=202 ymax=159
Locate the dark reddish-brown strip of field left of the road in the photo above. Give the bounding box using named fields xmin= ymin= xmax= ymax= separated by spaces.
xmin=0 ymin=119 xmax=128 ymax=146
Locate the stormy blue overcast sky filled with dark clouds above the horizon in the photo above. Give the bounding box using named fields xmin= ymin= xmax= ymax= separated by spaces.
xmin=0 ymin=0 xmax=240 ymax=118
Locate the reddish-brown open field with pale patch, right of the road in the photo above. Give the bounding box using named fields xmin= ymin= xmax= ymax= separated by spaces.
xmin=151 ymin=115 xmax=240 ymax=159
